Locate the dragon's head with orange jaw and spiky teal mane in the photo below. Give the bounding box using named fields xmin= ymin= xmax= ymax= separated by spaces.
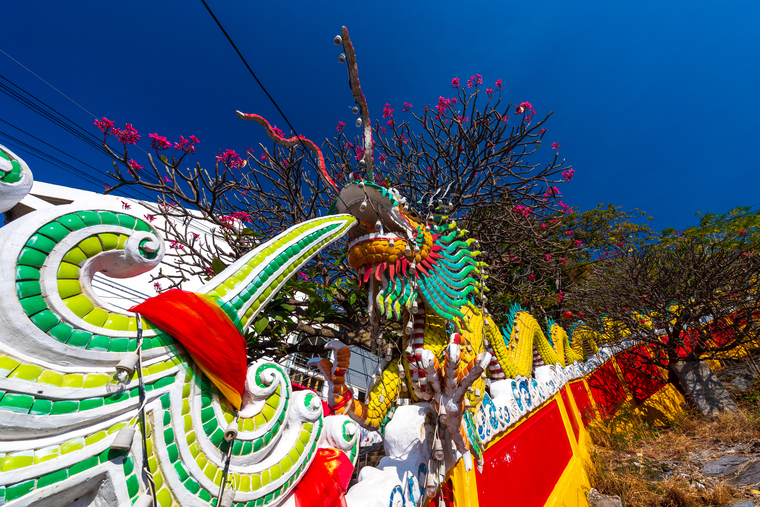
xmin=336 ymin=179 xmax=482 ymax=334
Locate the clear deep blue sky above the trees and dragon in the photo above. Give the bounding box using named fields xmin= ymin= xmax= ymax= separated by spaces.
xmin=0 ymin=0 xmax=760 ymax=229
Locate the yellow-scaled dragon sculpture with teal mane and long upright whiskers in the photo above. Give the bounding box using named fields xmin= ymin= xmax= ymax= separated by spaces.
xmin=238 ymin=27 xmax=598 ymax=467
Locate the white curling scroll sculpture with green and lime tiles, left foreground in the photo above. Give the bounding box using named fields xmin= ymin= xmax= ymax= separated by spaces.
xmin=0 ymin=147 xmax=358 ymax=507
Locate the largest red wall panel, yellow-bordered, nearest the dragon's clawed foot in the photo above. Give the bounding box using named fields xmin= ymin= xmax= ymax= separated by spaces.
xmin=476 ymin=400 xmax=573 ymax=507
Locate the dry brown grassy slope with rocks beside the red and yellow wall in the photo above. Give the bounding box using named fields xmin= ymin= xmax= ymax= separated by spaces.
xmin=590 ymin=359 xmax=760 ymax=507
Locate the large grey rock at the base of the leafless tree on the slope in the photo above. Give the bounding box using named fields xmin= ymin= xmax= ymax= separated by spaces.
xmin=675 ymin=361 xmax=739 ymax=416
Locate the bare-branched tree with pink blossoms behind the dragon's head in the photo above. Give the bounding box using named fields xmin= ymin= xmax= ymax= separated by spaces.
xmin=96 ymin=32 xmax=580 ymax=355
